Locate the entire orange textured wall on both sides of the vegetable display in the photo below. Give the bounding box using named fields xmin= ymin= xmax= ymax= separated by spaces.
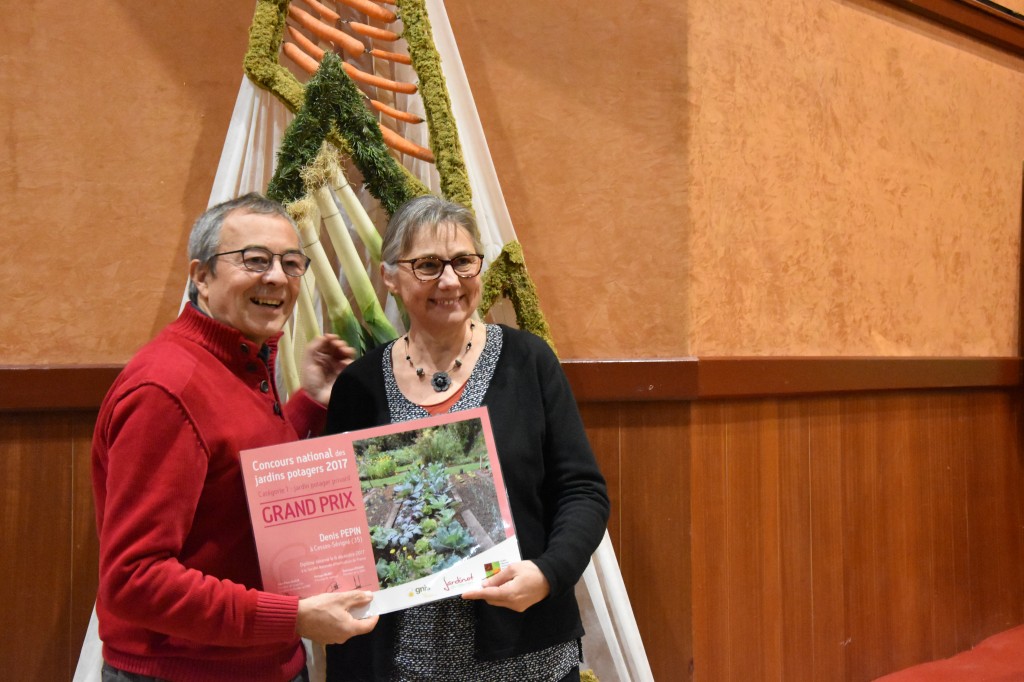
xmin=6 ymin=0 xmax=1024 ymax=365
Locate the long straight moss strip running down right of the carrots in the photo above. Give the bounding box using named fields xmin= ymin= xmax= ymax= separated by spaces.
xmin=397 ymin=0 xmax=473 ymax=207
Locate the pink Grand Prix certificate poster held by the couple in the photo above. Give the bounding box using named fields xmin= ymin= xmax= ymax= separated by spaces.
xmin=235 ymin=408 xmax=520 ymax=615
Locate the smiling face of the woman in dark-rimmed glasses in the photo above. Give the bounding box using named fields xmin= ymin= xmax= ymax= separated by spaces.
xmin=382 ymin=223 xmax=480 ymax=334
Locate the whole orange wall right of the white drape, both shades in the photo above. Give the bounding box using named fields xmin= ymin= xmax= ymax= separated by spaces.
xmin=446 ymin=0 xmax=1024 ymax=357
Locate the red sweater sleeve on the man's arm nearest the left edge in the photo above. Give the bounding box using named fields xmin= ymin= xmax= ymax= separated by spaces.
xmin=99 ymin=385 xmax=298 ymax=646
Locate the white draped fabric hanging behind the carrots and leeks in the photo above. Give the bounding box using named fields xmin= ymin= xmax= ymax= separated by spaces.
xmin=74 ymin=0 xmax=653 ymax=682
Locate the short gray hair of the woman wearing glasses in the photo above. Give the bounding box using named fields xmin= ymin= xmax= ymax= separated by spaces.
xmin=381 ymin=195 xmax=483 ymax=272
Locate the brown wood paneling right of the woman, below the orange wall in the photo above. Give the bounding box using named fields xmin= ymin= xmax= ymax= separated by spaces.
xmin=583 ymin=390 xmax=1024 ymax=682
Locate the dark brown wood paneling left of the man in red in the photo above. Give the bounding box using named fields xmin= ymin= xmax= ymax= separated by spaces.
xmin=0 ymin=412 xmax=97 ymax=682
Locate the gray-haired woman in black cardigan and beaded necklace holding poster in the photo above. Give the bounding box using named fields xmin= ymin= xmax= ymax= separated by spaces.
xmin=327 ymin=197 xmax=609 ymax=682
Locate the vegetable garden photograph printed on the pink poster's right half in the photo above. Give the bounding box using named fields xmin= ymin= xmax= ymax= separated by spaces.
xmin=352 ymin=411 xmax=513 ymax=589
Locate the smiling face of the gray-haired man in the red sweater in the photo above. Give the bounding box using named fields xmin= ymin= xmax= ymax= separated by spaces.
xmin=189 ymin=210 xmax=301 ymax=345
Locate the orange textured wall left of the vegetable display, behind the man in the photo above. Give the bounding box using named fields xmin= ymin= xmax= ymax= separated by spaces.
xmin=0 ymin=0 xmax=253 ymax=365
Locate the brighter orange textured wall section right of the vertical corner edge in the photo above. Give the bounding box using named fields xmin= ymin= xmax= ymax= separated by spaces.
xmin=687 ymin=0 xmax=1024 ymax=355
